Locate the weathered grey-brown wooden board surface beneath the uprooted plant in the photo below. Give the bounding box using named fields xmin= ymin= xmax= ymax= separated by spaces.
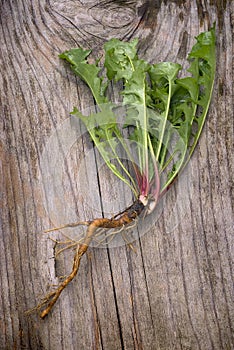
xmin=0 ymin=0 xmax=234 ymax=350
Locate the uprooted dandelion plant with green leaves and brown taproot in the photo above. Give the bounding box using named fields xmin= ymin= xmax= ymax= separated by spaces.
xmin=36 ymin=26 xmax=216 ymax=318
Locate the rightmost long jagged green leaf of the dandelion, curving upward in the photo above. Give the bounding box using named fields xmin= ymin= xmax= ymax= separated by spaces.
xmin=159 ymin=26 xmax=216 ymax=188
